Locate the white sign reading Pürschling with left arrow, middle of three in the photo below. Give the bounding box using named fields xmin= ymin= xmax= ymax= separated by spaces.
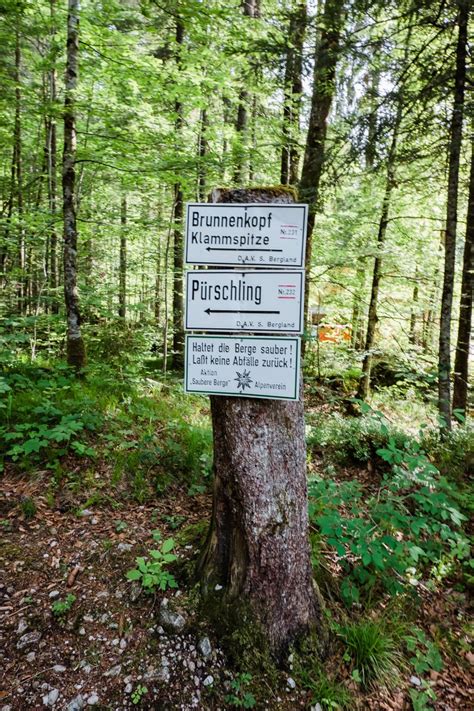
xmin=185 ymin=270 xmax=304 ymax=333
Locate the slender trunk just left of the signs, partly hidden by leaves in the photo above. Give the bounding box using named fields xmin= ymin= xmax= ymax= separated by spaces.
xmin=172 ymin=14 xmax=184 ymax=369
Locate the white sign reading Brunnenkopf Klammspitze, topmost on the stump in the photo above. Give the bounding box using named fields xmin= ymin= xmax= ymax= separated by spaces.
xmin=186 ymin=203 xmax=308 ymax=269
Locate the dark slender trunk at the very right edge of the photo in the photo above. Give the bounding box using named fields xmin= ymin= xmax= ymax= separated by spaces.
xmin=453 ymin=134 xmax=474 ymax=417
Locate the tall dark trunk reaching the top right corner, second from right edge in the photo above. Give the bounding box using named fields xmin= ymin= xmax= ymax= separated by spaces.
xmin=438 ymin=0 xmax=471 ymax=430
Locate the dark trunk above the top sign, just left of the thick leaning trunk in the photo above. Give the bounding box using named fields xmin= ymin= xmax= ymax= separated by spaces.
xmin=280 ymin=0 xmax=308 ymax=185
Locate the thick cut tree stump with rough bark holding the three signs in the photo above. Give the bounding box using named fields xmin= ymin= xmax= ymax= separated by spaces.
xmin=199 ymin=188 xmax=321 ymax=658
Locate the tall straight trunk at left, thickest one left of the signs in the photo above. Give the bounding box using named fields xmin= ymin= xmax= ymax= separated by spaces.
xmin=62 ymin=0 xmax=86 ymax=370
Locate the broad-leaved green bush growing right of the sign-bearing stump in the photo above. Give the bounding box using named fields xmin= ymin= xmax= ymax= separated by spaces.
xmin=309 ymin=412 xmax=469 ymax=603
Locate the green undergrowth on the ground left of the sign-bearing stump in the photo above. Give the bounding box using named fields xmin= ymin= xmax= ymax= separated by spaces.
xmin=0 ymin=359 xmax=212 ymax=501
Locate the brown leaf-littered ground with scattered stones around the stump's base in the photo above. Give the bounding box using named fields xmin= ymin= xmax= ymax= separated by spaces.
xmin=0 ymin=462 xmax=474 ymax=711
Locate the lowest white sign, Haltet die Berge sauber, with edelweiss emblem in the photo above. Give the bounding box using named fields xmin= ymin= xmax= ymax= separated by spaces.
xmin=184 ymin=336 xmax=300 ymax=400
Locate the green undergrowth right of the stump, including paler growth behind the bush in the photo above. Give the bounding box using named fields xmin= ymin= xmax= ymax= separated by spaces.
xmin=308 ymin=413 xmax=473 ymax=605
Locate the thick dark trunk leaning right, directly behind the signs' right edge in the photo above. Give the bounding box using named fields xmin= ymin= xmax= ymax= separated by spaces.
xmin=299 ymin=0 xmax=345 ymax=336
